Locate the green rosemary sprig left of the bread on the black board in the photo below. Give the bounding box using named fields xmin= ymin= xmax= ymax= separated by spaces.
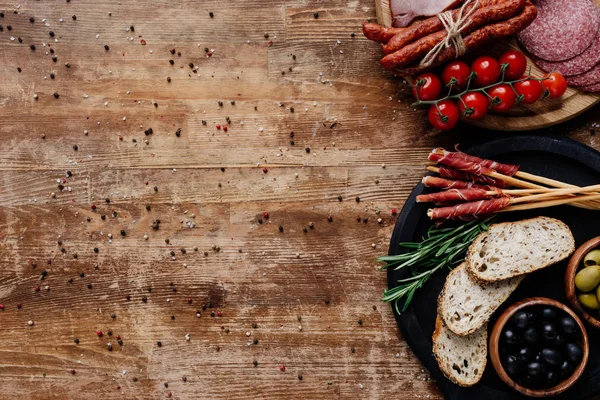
xmin=377 ymin=217 xmax=494 ymax=314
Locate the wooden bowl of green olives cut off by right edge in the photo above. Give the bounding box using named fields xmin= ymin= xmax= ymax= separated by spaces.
xmin=565 ymin=236 xmax=600 ymax=328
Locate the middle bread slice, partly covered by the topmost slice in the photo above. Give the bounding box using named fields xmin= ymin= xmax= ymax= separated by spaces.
xmin=438 ymin=262 xmax=524 ymax=336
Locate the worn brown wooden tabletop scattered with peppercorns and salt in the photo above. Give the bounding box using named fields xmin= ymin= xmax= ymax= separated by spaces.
xmin=0 ymin=0 xmax=600 ymax=399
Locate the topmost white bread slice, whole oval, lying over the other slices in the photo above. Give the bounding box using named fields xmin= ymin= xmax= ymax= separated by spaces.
xmin=466 ymin=217 xmax=575 ymax=282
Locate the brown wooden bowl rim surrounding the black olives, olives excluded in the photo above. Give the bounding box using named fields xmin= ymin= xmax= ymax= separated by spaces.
xmin=489 ymin=297 xmax=590 ymax=397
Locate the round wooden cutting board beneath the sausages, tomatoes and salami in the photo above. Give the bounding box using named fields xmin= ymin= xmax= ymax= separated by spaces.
xmin=375 ymin=0 xmax=600 ymax=131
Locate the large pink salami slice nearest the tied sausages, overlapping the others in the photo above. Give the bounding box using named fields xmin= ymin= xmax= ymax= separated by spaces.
xmin=518 ymin=0 xmax=600 ymax=62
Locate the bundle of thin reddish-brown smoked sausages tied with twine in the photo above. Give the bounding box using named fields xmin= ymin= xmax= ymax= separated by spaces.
xmin=363 ymin=0 xmax=537 ymax=75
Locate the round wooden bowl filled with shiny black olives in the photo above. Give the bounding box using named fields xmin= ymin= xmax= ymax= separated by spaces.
xmin=489 ymin=297 xmax=589 ymax=397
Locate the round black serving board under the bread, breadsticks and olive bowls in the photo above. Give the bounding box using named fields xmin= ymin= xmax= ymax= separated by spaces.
xmin=388 ymin=136 xmax=600 ymax=400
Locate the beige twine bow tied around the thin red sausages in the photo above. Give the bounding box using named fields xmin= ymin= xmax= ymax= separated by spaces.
xmin=421 ymin=0 xmax=479 ymax=67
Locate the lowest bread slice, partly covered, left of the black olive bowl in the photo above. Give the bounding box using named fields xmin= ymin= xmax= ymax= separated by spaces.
xmin=433 ymin=315 xmax=487 ymax=386
